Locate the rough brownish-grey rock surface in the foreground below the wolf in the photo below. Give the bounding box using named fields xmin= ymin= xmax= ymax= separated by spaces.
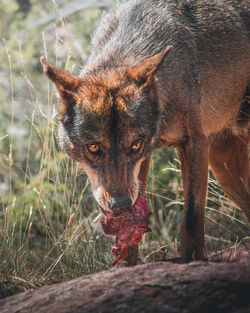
xmin=0 ymin=262 xmax=250 ymax=313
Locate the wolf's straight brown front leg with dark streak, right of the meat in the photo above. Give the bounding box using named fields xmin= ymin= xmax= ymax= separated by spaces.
xmin=179 ymin=137 xmax=208 ymax=262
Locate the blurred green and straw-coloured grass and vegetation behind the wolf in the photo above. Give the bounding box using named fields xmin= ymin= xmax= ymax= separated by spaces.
xmin=0 ymin=0 xmax=249 ymax=297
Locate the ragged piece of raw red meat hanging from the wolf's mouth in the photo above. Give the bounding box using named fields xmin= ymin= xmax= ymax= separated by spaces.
xmin=101 ymin=198 xmax=151 ymax=266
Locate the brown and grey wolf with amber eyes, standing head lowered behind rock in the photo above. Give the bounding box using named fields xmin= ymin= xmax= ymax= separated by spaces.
xmin=41 ymin=0 xmax=250 ymax=262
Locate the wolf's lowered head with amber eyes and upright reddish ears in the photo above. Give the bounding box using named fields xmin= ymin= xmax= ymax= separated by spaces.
xmin=41 ymin=48 xmax=169 ymax=212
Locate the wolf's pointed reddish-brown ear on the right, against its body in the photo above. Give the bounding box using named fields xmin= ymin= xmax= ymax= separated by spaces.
xmin=127 ymin=46 xmax=172 ymax=86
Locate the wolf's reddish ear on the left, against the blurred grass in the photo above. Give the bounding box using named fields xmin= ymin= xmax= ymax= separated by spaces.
xmin=40 ymin=57 xmax=82 ymax=119
